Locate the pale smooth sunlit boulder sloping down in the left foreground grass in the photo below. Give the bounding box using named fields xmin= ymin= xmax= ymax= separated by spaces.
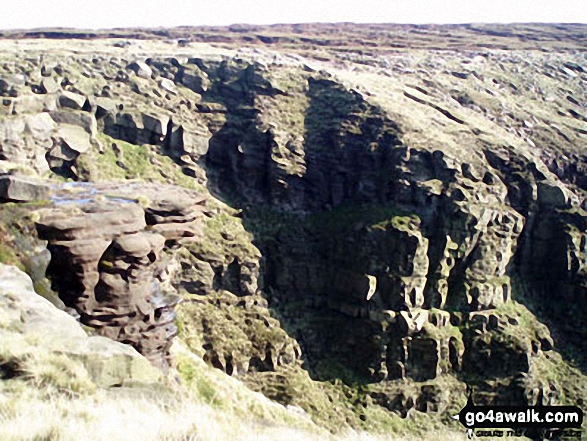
xmin=0 ymin=264 xmax=161 ymax=387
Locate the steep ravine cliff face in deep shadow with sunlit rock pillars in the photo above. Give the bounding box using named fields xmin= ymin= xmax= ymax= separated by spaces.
xmin=195 ymin=56 xmax=585 ymax=418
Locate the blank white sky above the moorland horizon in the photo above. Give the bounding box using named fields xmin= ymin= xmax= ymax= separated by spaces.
xmin=0 ymin=0 xmax=587 ymax=29
